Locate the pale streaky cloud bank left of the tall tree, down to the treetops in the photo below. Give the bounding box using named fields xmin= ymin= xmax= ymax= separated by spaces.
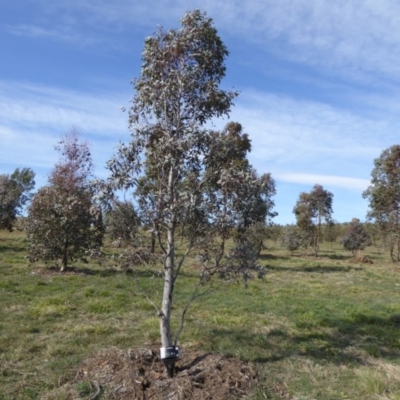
xmin=0 ymin=82 xmax=129 ymax=186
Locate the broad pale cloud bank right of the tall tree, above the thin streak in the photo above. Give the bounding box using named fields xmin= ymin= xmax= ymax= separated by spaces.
xmin=231 ymin=92 xmax=394 ymax=177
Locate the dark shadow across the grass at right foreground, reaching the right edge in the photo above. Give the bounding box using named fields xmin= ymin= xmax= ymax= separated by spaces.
xmin=209 ymin=313 xmax=400 ymax=365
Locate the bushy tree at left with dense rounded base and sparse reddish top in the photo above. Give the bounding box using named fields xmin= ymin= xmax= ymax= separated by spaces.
xmin=26 ymin=129 xmax=104 ymax=271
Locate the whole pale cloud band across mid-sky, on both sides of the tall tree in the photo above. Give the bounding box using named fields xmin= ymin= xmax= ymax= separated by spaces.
xmin=0 ymin=82 xmax=392 ymax=187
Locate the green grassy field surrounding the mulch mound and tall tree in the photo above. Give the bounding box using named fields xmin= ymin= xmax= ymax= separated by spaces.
xmin=0 ymin=232 xmax=400 ymax=400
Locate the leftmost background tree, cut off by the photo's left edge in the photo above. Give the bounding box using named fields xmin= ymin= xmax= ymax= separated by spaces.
xmin=0 ymin=168 xmax=35 ymax=231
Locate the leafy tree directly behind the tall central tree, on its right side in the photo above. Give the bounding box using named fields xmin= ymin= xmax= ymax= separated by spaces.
xmin=204 ymin=165 xmax=276 ymax=272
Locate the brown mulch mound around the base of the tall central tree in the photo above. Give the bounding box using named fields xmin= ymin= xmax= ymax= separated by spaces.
xmin=74 ymin=348 xmax=258 ymax=400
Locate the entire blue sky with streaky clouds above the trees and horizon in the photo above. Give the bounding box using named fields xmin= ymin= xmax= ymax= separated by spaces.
xmin=0 ymin=0 xmax=400 ymax=224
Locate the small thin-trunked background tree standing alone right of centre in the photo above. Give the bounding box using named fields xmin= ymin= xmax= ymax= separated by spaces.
xmin=293 ymin=184 xmax=333 ymax=257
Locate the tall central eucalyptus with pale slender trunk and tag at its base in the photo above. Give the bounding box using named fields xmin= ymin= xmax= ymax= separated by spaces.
xmin=105 ymin=10 xmax=276 ymax=377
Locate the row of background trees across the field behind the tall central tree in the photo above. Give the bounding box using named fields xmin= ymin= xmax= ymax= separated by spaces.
xmin=0 ymin=144 xmax=400 ymax=262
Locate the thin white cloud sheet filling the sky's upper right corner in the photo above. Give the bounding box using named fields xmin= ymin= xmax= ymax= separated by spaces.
xmin=212 ymin=0 xmax=400 ymax=79
